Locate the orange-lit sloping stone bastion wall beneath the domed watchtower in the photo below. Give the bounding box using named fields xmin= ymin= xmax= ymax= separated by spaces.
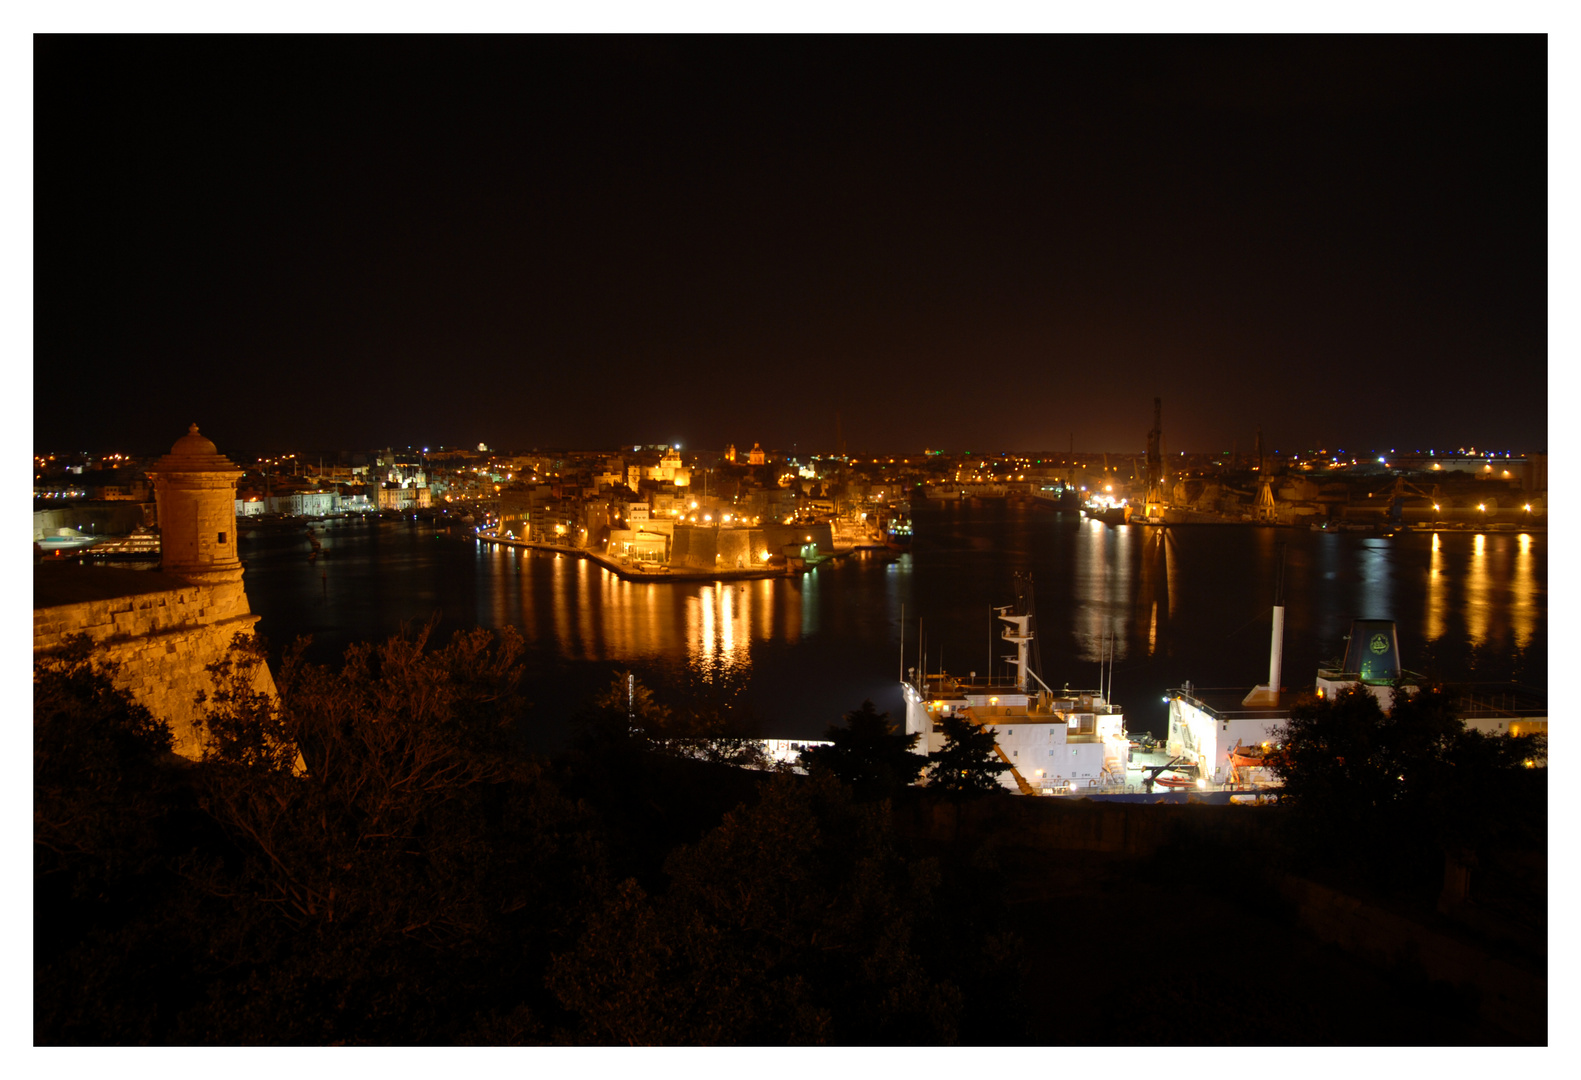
xmin=33 ymin=566 xmax=275 ymax=757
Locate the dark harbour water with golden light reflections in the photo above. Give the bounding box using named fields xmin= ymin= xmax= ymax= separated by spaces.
xmin=240 ymin=500 xmax=1548 ymax=750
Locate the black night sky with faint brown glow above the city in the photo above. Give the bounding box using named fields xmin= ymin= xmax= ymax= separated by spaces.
xmin=33 ymin=36 xmax=1548 ymax=455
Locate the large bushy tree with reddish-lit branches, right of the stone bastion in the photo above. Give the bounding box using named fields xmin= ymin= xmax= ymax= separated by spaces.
xmin=177 ymin=631 xmax=602 ymax=1044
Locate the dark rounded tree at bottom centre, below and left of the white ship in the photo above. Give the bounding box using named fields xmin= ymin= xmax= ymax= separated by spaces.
xmin=549 ymin=770 xmax=961 ymax=1045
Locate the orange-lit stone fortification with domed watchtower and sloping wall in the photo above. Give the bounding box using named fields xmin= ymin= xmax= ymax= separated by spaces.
xmin=33 ymin=424 xmax=275 ymax=757
